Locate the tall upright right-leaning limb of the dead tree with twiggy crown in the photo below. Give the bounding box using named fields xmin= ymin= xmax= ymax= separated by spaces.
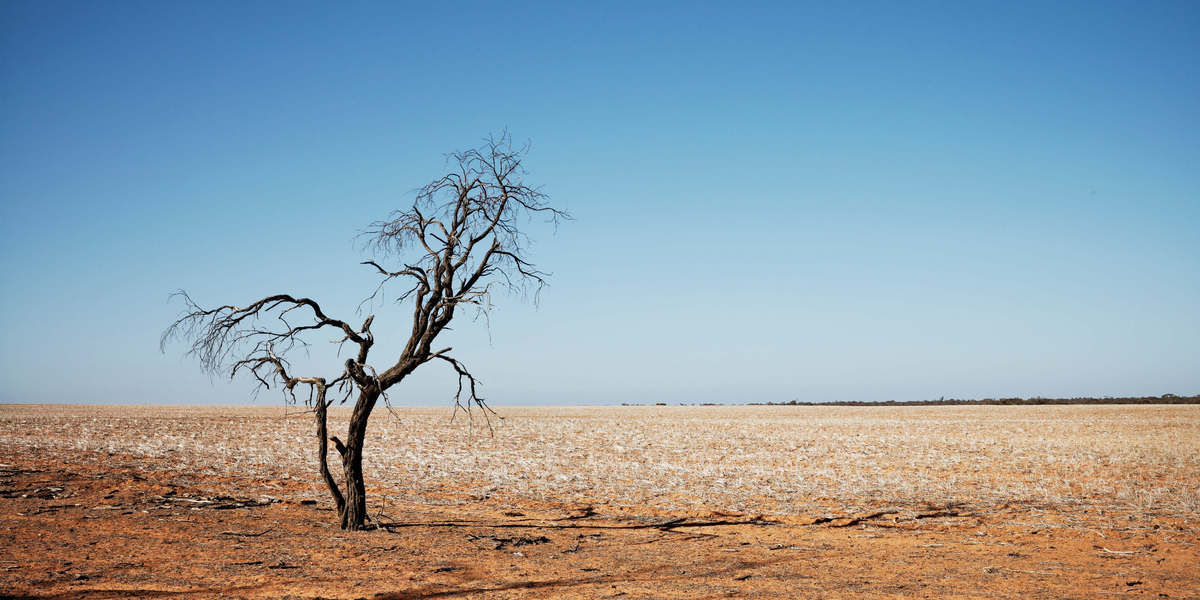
xmin=364 ymin=133 xmax=570 ymax=389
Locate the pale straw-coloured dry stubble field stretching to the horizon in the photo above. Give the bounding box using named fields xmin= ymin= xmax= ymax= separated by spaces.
xmin=0 ymin=406 xmax=1200 ymax=518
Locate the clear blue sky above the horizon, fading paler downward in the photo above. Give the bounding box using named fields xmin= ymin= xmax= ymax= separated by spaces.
xmin=0 ymin=1 xmax=1200 ymax=407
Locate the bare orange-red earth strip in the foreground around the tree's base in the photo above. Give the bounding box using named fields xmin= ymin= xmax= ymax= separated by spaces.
xmin=0 ymin=405 xmax=1200 ymax=600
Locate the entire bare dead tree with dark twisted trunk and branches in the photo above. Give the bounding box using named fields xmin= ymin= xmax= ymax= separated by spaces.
xmin=161 ymin=134 xmax=570 ymax=529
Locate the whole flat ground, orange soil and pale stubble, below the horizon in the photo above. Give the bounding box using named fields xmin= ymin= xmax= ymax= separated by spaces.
xmin=0 ymin=404 xmax=1200 ymax=599
